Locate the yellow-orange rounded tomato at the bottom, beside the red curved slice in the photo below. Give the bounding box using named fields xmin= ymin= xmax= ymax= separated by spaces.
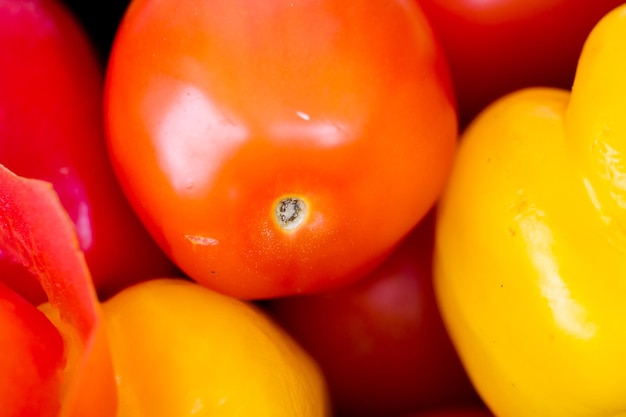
xmin=103 ymin=279 xmax=330 ymax=417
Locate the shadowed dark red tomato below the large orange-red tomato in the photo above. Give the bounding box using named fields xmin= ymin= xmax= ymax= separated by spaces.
xmin=263 ymin=216 xmax=478 ymax=417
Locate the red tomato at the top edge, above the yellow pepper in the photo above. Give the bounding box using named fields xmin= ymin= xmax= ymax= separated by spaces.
xmin=416 ymin=0 xmax=624 ymax=126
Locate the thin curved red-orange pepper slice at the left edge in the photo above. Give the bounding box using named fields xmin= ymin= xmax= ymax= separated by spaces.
xmin=0 ymin=165 xmax=116 ymax=417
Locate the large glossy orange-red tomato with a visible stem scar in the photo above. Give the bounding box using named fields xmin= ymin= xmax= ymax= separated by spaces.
xmin=105 ymin=0 xmax=457 ymax=299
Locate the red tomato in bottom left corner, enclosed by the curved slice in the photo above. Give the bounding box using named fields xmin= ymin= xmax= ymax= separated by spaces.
xmin=0 ymin=281 xmax=64 ymax=417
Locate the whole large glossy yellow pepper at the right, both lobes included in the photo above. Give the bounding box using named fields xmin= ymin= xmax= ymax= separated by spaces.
xmin=435 ymin=5 xmax=626 ymax=417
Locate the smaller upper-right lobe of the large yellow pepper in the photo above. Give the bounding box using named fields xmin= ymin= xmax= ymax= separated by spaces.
xmin=565 ymin=6 xmax=626 ymax=247
